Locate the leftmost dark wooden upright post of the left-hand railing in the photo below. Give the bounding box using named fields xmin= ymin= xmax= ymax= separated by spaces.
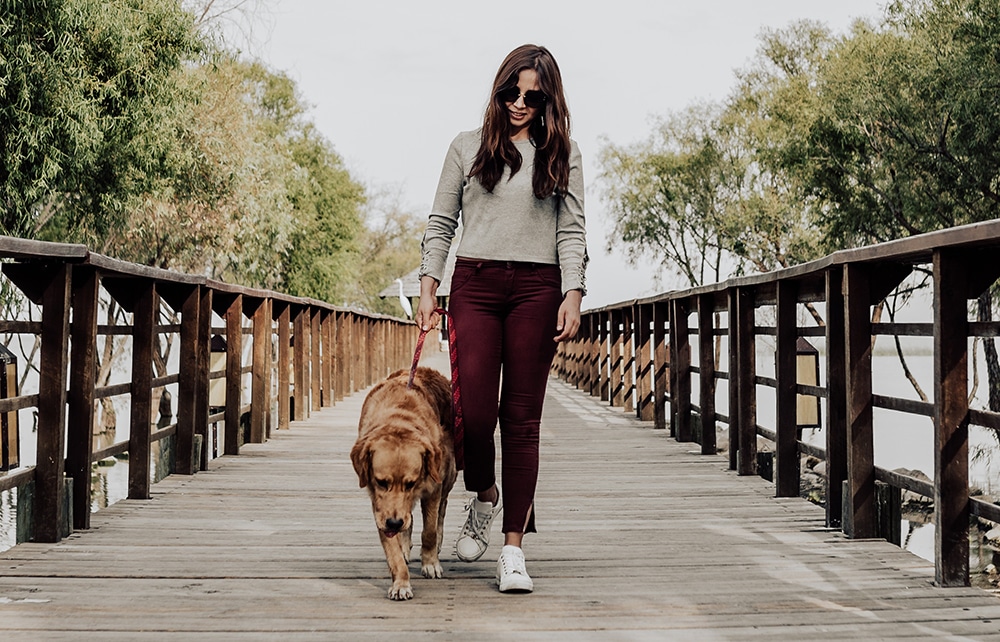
xmin=32 ymin=264 xmax=72 ymax=542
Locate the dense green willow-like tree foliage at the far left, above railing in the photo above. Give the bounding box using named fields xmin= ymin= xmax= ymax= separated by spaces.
xmin=0 ymin=0 xmax=201 ymax=240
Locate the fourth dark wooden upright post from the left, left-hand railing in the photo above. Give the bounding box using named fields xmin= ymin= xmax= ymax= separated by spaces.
xmin=173 ymin=286 xmax=201 ymax=475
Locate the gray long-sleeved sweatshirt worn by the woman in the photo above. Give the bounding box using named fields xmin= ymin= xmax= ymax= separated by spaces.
xmin=420 ymin=129 xmax=588 ymax=294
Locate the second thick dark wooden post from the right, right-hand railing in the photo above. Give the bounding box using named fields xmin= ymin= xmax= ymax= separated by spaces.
xmin=843 ymin=263 xmax=876 ymax=539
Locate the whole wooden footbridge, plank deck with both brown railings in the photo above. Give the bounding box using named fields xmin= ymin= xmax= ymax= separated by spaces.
xmin=0 ymin=223 xmax=1000 ymax=640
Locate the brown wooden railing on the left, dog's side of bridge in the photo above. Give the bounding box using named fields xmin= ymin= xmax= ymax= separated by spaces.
xmin=0 ymin=237 xmax=417 ymax=542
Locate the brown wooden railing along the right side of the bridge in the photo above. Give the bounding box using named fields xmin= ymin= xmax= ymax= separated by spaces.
xmin=554 ymin=221 xmax=1000 ymax=586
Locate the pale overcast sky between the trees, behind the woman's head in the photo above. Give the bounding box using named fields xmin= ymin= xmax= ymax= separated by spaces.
xmin=254 ymin=0 xmax=885 ymax=308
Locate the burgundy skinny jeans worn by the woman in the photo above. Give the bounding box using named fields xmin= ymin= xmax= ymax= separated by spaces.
xmin=448 ymin=258 xmax=562 ymax=533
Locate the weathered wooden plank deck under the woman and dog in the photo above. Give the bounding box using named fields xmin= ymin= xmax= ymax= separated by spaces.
xmin=0 ymin=352 xmax=1000 ymax=641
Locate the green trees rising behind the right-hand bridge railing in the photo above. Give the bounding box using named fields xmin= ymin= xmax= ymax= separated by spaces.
xmin=602 ymin=0 xmax=1000 ymax=284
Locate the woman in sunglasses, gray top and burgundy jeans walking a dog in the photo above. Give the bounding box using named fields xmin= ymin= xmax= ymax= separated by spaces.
xmin=416 ymin=45 xmax=587 ymax=593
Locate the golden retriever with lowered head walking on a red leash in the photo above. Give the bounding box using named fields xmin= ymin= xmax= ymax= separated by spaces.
xmin=351 ymin=368 xmax=458 ymax=600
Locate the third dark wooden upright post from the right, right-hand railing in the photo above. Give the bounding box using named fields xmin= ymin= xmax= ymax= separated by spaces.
xmin=826 ymin=268 xmax=847 ymax=528
